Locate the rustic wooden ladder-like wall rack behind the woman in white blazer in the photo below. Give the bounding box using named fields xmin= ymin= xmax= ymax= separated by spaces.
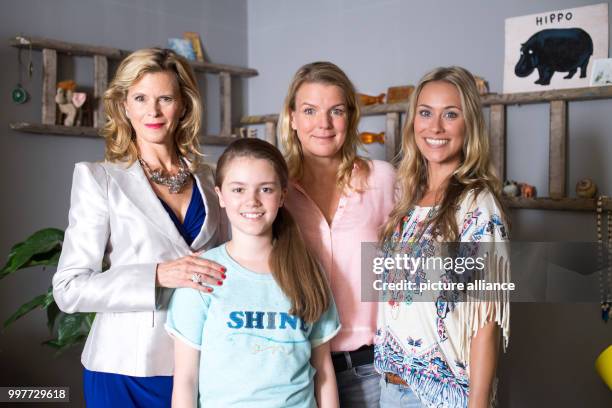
xmin=9 ymin=35 xmax=258 ymax=145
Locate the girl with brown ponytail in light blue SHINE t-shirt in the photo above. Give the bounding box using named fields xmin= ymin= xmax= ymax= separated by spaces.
xmin=166 ymin=139 xmax=340 ymax=408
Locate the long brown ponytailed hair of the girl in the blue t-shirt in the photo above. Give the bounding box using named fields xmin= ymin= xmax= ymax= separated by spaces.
xmin=215 ymin=139 xmax=331 ymax=323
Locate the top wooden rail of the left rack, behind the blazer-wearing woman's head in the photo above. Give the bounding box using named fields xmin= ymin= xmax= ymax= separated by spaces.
xmin=9 ymin=35 xmax=259 ymax=77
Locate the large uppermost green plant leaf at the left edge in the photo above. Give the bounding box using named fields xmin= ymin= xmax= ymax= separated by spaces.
xmin=0 ymin=228 xmax=64 ymax=279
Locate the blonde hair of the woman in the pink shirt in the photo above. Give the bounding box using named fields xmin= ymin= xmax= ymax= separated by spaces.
xmin=278 ymin=61 xmax=370 ymax=191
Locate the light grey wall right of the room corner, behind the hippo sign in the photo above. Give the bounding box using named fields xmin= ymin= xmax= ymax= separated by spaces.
xmin=248 ymin=0 xmax=612 ymax=407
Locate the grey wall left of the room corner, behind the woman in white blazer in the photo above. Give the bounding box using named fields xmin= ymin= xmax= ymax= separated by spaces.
xmin=0 ymin=0 xmax=247 ymax=406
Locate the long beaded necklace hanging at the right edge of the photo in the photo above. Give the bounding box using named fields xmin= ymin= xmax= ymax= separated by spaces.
xmin=597 ymin=196 xmax=612 ymax=323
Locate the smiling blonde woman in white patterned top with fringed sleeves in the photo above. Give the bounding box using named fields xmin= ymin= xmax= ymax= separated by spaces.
xmin=375 ymin=67 xmax=509 ymax=408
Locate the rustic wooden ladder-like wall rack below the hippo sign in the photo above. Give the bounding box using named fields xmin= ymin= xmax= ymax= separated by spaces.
xmin=241 ymin=86 xmax=612 ymax=211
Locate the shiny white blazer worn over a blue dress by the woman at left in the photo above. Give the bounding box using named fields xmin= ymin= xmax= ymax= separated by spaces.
xmin=53 ymin=162 xmax=227 ymax=377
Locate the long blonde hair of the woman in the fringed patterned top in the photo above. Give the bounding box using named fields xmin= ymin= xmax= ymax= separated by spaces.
xmin=381 ymin=67 xmax=503 ymax=243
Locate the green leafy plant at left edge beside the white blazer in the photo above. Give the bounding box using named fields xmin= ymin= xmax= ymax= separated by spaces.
xmin=0 ymin=228 xmax=95 ymax=353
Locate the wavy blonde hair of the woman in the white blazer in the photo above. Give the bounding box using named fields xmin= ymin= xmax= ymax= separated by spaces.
xmin=101 ymin=48 xmax=202 ymax=170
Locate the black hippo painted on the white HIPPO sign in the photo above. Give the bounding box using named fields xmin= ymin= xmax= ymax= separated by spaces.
xmin=514 ymin=28 xmax=593 ymax=85
